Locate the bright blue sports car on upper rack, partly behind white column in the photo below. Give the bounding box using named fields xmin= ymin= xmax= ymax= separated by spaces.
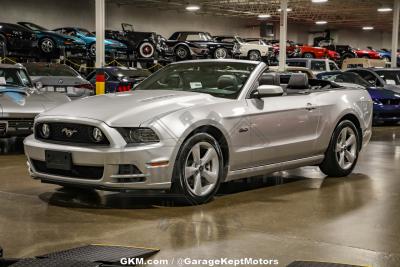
xmin=54 ymin=27 xmax=128 ymax=57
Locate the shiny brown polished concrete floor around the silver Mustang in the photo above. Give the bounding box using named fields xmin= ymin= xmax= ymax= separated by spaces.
xmin=0 ymin=127 xmax=400 ymax=267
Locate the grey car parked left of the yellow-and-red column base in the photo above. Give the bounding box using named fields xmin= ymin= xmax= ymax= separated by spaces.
xmin=23 ymin=63 xmax=94 ymax=100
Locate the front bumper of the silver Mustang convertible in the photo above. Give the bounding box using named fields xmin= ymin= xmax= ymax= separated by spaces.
xmin=24 ymin=119 xmax=175 ymax=191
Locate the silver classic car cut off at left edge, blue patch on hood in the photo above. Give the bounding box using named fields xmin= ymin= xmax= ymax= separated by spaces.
xmin=0 ymin=64 xmax=70 ymax=137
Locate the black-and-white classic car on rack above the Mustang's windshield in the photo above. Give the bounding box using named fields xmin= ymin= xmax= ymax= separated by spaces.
xmin=165 ymin=31 xmax=234 ymax=60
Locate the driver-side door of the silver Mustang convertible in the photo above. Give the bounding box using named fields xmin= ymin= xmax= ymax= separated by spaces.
xmin=247 ymin=86 xmax=320 ymax=166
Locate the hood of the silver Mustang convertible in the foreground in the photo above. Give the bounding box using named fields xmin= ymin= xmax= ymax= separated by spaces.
xmin=41 ymin=90 xmax=227 ymax=127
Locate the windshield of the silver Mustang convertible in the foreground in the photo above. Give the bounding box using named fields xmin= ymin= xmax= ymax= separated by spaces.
xmin=136 ymin=62 xmax=257 ymax=99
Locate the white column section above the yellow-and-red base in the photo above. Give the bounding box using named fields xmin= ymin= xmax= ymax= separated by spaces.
xmin=95 ymin=0 xmax=106 ymax=68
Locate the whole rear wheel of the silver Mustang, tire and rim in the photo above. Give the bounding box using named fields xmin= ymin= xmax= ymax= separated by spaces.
xmin=319 ymin=120 xmax=361 ymax=177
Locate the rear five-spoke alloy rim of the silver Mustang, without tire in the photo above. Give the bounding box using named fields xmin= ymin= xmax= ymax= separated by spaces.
xmin=335 ymin=127 xmax=357 ymax=170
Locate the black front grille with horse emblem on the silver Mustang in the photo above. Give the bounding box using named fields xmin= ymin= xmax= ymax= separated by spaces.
xmin=35 ymin=122 xmax=110 ymax=145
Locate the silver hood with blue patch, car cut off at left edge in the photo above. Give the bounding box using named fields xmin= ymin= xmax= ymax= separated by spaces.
xmin=0 ymin=86 xmax=69 ymax=118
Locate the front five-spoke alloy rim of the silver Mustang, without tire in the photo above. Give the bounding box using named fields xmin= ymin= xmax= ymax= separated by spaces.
xmin=184 ymin=142 xmax=220 ymax=196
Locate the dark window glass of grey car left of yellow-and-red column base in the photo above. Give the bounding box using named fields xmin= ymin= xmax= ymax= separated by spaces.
xmin=25 ymin=64 xmax=79 ymax=77
